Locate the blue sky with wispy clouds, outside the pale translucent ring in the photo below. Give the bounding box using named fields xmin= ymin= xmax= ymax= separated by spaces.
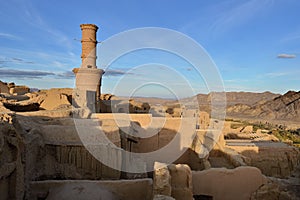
xmin=0 ymin=0 xmax=300 ymax=97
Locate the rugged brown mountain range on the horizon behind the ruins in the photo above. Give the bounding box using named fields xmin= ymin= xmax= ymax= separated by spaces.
xmin=138 ymin=91 xmax=300 ymax=123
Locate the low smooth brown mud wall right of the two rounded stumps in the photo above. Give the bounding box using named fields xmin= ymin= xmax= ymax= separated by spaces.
xmin=192 ymin=167 xmax=266 ymax=200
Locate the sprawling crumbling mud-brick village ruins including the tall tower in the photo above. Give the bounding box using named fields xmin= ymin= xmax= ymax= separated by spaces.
xmin=0 ymin=24 xmax=300 ymax=200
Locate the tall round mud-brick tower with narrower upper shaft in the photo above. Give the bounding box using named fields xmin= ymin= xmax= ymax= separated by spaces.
xmin=73 ymin=24 xmax=104 ymax=112
